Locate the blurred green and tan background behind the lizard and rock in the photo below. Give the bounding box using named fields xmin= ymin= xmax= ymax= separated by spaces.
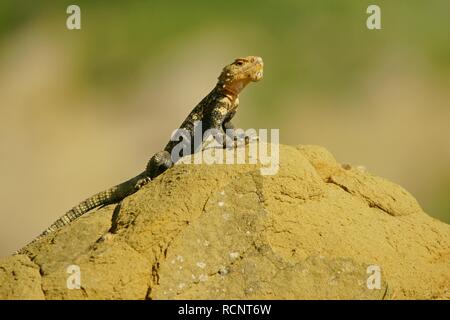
xmin=0 ymin=0 xmax=450 ymax=256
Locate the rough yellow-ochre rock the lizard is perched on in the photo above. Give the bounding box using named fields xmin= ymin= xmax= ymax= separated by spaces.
xmin=0 ymin=145 xmax=450 ymax=299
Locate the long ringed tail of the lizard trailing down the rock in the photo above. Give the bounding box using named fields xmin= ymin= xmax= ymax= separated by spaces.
xmin=14 ymin=171 xmax=149 ymax=255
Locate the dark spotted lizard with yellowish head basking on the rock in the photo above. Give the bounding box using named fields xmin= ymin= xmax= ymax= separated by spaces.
xmin=14 ymin=56 xmax=264 ymax=254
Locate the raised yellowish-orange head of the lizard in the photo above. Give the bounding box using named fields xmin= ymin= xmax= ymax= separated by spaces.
xmin=219 ymin=56 xmax=264 ymax=94
